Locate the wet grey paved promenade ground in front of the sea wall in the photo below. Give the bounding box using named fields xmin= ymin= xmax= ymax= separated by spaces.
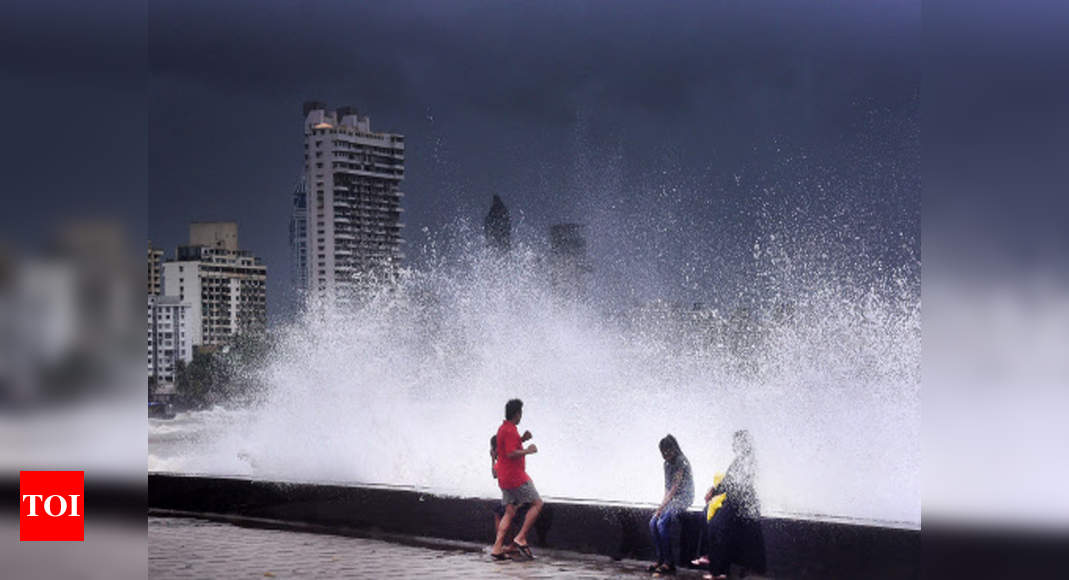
xmin=149 ymin=517 xmax=700 ymax=580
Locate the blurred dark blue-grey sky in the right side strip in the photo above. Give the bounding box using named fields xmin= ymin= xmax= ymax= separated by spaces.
xmin=924 ymin=0 xmax=1069 ymax=275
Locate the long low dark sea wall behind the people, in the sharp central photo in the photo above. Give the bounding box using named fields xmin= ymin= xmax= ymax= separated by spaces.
xmin=149 ymin=474 xmax=920 ymax=579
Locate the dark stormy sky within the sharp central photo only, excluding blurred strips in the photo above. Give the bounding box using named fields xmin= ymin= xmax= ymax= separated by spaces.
xmin=149 ymin=1 xmax=919 ymax=320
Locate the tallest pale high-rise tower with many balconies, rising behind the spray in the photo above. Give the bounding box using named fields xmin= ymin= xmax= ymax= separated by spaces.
xmin=291 ymin=103 xmax=404 ymax=303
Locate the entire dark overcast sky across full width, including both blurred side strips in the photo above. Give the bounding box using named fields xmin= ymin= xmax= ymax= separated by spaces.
xmin=6 ymin=0 xmax=1069 ymax=322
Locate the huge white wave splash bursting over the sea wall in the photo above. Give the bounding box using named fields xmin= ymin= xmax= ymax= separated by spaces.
xmin=150 ymin=225 xmax=920 ymax=524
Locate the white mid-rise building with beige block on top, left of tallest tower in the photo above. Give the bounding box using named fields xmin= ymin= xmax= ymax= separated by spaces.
xmin=164 ymin=222 xmax=267 ymax=346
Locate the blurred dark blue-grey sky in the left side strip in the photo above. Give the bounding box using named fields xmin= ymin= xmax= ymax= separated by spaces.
xmin=0 ymin=0 xmax=148 ymax=247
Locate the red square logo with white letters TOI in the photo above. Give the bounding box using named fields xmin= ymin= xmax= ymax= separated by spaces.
xmin=18 ymin=471 xmax=86 ymax=542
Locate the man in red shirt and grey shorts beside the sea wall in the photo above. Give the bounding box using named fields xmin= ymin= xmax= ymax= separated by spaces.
xmin=490 ymin=398 xmax=542 ymax=560
